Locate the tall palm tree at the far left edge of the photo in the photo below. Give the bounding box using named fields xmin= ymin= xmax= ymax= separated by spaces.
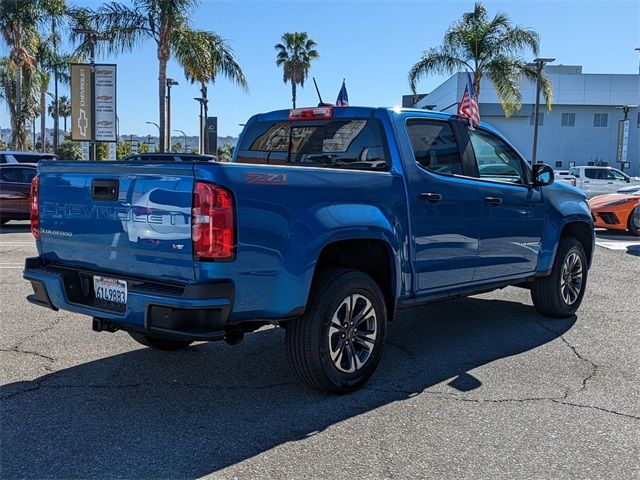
xmin=0 ymin=0 xmax=39 ymax=150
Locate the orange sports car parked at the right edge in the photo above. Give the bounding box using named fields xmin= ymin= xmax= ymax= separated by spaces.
xmin=589 ymin=190 xmax=640 ymax=236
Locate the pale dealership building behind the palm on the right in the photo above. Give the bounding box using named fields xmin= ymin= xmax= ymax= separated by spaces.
xmin=403 ymin=65 xmax=640 ymax=175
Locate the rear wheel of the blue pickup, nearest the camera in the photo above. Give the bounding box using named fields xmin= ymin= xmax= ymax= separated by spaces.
xmin=286 ymin=268 xmax=387 ymax=393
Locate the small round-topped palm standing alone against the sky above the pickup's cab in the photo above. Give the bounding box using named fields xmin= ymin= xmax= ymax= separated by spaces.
xmin=275 ymin=32 xmax=320 ymax=108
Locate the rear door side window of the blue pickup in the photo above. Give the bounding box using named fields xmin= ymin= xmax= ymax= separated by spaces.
xmin=407 ymin=119 xmax=462 ymax=175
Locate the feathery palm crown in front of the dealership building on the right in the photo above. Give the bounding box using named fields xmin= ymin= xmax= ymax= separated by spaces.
xmin=409 ymin=3 xmax=553 ymax=117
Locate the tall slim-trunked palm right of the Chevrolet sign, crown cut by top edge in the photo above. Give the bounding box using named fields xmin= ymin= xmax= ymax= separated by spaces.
xmin=77 ymin=0 xmax=246 ymax=152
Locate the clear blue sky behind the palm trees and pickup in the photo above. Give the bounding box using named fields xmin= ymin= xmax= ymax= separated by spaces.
xmin=0 ymin=0 xmax=640 ymax=136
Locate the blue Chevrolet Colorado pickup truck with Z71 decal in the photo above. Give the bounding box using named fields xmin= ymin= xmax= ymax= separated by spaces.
xmin=24 ymin=107 xmax=594 ymax=392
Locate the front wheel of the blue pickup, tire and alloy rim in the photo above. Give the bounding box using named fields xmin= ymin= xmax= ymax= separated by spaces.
xmin=531 ymin=237 xmax=588 ymax=318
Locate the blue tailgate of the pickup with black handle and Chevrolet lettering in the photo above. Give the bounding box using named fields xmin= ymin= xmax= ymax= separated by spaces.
xmin=39 ymin=161 xmax=194 ymax=282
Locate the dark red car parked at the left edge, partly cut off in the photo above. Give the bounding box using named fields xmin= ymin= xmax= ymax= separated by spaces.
xmin=0 ymin=163 xmax=38 ymax=225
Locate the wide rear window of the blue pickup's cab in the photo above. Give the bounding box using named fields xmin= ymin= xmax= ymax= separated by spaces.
xmin=236 ymin=119 xmax=389 ymax=170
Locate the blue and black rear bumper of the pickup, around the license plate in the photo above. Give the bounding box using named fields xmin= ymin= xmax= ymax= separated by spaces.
xmin=23 ymin=257 xmax=235 ymax=341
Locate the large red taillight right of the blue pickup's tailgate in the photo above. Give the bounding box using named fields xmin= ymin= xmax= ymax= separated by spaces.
xmin=191 ymin=182 xmax=235 ymax=260
